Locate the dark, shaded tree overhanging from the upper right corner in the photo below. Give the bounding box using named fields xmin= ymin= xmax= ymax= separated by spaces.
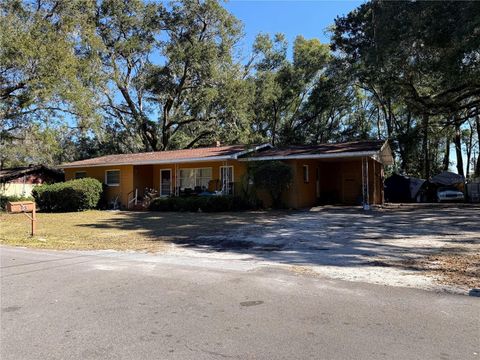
xmin=332 ymin=0 xmax=480 ymax=177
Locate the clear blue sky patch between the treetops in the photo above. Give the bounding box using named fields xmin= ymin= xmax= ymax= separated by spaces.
xmin=223 ymin=0 xmax=364 ymax=54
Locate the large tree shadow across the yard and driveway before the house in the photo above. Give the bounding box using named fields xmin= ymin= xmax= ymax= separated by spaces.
xmin=82 ymin=207 xmax=480 ymax=292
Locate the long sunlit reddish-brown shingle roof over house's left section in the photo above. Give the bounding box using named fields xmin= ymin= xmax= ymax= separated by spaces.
xmin=61 ymin=145 xmax=268 ymax=168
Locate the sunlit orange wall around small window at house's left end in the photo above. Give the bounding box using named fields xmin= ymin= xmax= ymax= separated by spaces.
xmin=65 ymin=165 xmax=134 ymax=207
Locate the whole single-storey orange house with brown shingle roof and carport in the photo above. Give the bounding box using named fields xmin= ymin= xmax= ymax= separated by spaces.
xmin=62 ymin=141 xmax=393 ymax=208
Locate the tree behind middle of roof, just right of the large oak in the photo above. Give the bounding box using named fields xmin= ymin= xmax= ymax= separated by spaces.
xmin=248 ymin=34 xmax=329 ymax=145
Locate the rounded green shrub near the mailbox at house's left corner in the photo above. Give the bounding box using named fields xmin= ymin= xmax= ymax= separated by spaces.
xmin=32 ymin=178 xmax=102 ymax=212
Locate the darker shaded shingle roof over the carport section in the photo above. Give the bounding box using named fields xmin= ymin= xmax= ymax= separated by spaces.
xmin=244 ymin=140 xmax=385 ymax=158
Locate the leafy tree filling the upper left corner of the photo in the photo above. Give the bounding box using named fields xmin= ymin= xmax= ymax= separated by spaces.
xmin=0 ymin=0 xmax=102 ymax=168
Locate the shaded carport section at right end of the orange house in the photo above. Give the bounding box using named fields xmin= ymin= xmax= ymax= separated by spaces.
xmin=242 ymin=141 xmax=393 ymax=208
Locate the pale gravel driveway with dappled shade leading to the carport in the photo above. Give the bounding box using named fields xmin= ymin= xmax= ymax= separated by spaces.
xmin=175 ymin=206 xmax=480 ymax=293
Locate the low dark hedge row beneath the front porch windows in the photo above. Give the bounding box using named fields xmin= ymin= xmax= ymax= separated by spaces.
xmin=149 ymin=196 xmax=257 ymax=212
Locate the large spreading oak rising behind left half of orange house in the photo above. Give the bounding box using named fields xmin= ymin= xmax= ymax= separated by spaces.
xmin=92 ymin=0 xmax=246 ymax=151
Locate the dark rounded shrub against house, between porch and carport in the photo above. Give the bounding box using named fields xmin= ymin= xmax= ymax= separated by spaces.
xmin=250 ymin=161 xmax=293 ymax=208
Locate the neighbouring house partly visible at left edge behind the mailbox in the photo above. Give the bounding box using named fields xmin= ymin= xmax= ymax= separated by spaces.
xmin=0 ymin=165 xmax=64 ymax=196
